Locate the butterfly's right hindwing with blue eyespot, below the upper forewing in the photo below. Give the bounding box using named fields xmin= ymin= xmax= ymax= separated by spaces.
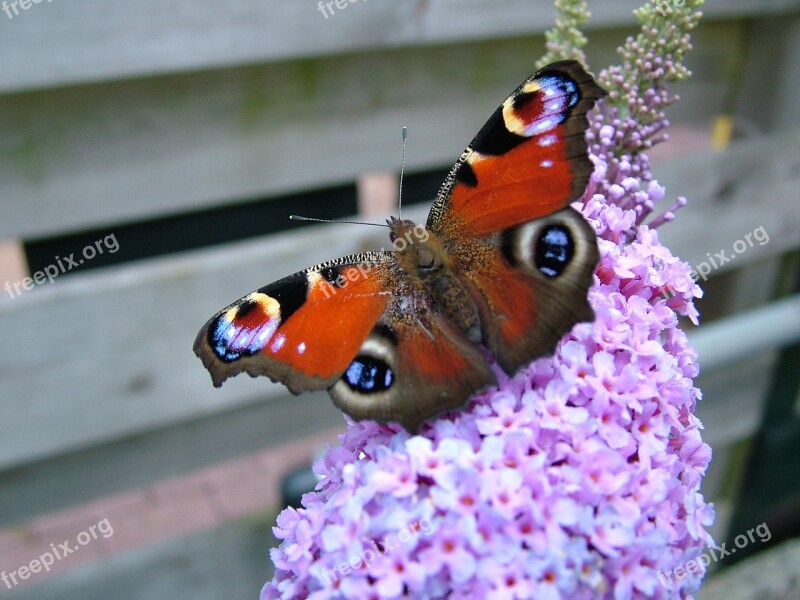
xmin=456 ymin=208 xmax=599 ymax=374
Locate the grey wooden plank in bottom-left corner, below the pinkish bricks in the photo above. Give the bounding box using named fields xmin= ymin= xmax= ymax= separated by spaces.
xmin=3 ymin=515 xmax=277 ymax=600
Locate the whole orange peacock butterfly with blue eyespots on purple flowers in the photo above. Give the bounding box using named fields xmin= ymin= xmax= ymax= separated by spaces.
xmin=194 ymin=61 xmax=605 ymax=433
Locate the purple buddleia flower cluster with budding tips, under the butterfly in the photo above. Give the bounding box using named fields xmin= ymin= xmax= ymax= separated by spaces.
xmin=261 ymin=0 xmax=713 ymax=600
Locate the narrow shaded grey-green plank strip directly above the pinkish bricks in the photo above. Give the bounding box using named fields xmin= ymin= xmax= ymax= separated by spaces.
xmin=0 ymin=390 xmax=344 ymax=527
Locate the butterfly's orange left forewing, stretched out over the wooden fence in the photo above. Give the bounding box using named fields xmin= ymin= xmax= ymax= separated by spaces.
xmin=194 ymin=252 xmax=394 ymax=392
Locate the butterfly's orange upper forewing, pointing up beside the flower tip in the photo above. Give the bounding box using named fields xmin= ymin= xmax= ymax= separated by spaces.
xmin=427 ymin=61 xmax=605 ymax=238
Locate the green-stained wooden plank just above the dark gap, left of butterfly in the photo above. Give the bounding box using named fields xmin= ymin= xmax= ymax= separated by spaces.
xmin=0 ymin=22 xmax=764 ymax=239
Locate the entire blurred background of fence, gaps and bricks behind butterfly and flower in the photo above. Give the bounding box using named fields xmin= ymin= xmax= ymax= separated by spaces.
xmin=0 ymin=0 xmax=800 ymax=600
